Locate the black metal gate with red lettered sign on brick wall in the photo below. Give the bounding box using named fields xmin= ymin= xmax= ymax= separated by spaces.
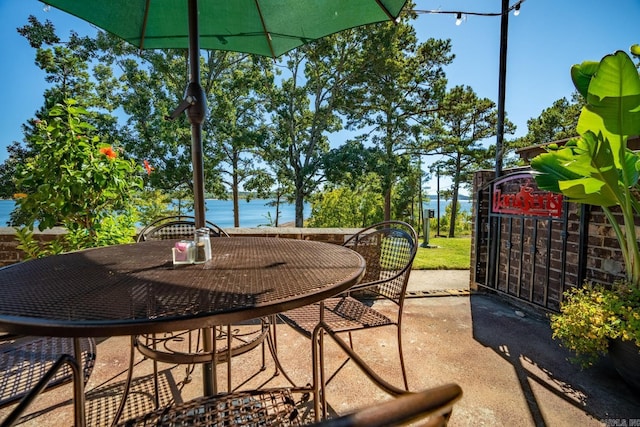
xmin=475 ymin=172 xmax=584 ymax=311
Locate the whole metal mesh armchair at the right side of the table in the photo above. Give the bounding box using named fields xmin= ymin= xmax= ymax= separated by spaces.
xmin=279 ymin=221 xmax=418 ymax=390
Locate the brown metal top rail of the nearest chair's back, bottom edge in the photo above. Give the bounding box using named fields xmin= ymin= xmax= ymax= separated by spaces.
xmin=314 ymin=384 xmax=462 ymax=427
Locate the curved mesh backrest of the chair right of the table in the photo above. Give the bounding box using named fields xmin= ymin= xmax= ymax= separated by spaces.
xmin=344 ymin=221 xmax=418 ymax=304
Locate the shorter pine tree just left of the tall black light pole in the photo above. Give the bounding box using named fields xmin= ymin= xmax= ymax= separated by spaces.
xmin=432 ymin=86 xmax=514 ymax=237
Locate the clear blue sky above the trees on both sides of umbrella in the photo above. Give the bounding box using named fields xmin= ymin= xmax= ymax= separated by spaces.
xmin=0 ymin=0 xmax=640 ymax=194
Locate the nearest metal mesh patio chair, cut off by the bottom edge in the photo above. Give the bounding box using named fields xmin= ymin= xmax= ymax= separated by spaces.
xmin=118 ymin=324 xmax=462 ymax=427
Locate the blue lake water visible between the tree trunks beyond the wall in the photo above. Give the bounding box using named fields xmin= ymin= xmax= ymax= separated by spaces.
xmin=0 ymin=199 xmax=471 ymax=228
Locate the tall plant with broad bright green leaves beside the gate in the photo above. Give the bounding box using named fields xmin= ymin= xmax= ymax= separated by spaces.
xmin=531 ymin=51 xmax=640 ymax=286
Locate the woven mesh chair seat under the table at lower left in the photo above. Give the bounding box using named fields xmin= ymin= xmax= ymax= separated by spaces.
xmin=0 ymin=334 xmax=96 ymax=408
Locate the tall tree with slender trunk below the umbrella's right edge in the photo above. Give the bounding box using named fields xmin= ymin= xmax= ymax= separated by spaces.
xmin=262 ymin=31 xmax=359 ymax=227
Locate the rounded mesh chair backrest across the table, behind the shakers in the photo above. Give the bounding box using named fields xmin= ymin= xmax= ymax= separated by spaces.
xmin=137 ymin=215 xmax=229 ymax=242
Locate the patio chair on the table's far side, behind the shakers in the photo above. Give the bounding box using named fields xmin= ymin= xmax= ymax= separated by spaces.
xmin=134 ymin=216 xmax=269 ymax=406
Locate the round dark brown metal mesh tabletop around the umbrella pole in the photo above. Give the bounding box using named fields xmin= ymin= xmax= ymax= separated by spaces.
xmin=0 ymin=237 xmax=365 ymax=337
